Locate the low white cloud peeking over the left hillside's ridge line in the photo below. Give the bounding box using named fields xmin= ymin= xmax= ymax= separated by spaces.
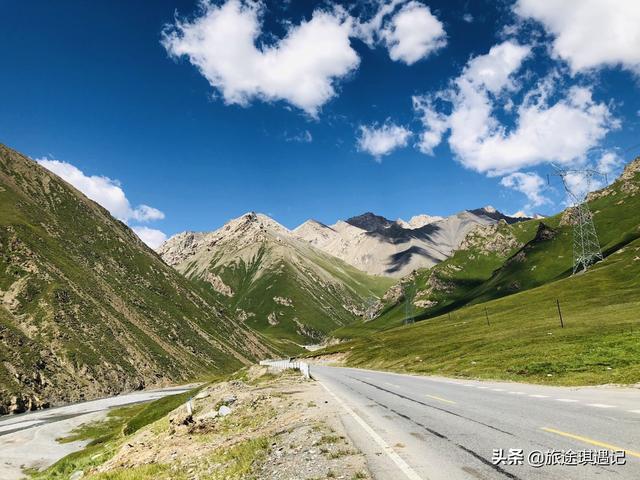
xmin=36 ymin=158 xmax=164 ymax=248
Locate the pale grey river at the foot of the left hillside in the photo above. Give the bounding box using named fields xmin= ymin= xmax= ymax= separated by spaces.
xmin=0 ymin=386 xmax=191 ymax=480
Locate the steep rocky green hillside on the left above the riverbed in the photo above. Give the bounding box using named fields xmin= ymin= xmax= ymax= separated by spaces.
xmin=0 ymin=145 xmax=265 ymax=413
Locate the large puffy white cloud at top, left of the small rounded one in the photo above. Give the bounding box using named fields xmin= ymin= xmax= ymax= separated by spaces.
xmin=162 ymin=0 xmax=360 ymax=116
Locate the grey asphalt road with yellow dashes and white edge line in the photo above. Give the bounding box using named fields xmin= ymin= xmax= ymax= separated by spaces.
xmin=311 ymin=365 xmax=640 ymax=480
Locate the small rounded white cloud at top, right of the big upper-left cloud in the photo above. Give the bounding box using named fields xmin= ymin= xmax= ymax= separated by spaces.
xmin=380 ymin=1 xmax=447 ymax=65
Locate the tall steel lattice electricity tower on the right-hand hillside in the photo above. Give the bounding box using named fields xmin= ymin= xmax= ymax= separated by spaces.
xmin=553 ymin=165 xmax=604 ymax=275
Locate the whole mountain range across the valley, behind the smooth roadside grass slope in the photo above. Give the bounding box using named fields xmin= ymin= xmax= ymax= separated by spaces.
xmin=0 ymin=134 xmax=640 ymax=414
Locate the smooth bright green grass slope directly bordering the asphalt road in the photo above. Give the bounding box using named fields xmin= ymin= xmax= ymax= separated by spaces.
xmin=316 ymin=234 xmax=640 ymax=384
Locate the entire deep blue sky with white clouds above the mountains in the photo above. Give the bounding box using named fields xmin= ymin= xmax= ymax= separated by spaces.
xmin=0 ymin=0 xmax=640 ymax=248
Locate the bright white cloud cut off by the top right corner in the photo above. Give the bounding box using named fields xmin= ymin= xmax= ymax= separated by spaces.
xmin=514 ymin=0 xmax=640 ymax=75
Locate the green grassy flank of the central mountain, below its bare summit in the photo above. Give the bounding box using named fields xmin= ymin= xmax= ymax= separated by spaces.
xmin=178 ymin=229 xmax=393 ymax=353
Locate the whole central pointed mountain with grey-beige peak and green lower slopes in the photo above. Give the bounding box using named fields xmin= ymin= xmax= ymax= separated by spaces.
xmin=160 ymin=213 xmax=393 ymax=353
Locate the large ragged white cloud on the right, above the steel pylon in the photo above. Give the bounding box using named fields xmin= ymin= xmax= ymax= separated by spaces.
xmin=414 ymin=41 xmax=619 ymax=175
